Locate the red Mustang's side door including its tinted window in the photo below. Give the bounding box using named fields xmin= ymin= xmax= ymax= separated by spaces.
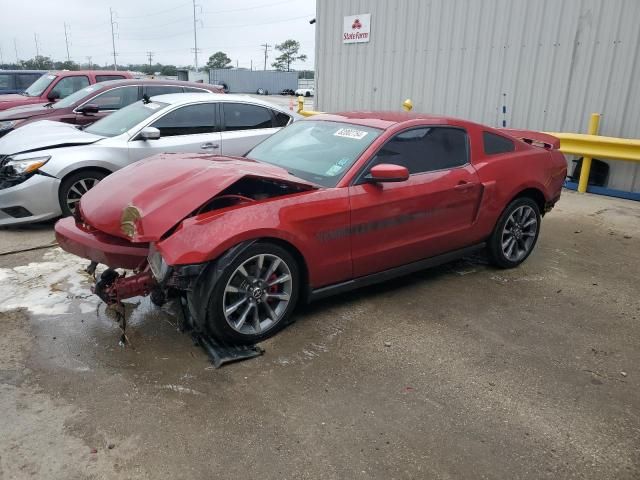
xmin=349 ymin=127 xmax=482 ymax=277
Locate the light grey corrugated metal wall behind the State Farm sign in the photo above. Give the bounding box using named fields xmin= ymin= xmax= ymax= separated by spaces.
xmin=316 ymin=0 xmax=640 ymax=192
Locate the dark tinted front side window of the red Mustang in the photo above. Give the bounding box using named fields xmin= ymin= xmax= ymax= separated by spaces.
xmin=370 ymin=127 xmax=469 ymax=175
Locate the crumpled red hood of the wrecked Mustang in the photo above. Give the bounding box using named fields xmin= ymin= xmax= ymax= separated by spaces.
xmin=80 ymin=153 xmax=317 ymax=242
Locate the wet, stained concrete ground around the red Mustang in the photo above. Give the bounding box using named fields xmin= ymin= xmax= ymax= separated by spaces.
xmin=0 ymin=192 xmax=640 ymax=480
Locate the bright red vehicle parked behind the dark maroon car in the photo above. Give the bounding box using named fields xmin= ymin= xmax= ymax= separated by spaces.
xmin=0 ymin=70 xmax=133 ymax=110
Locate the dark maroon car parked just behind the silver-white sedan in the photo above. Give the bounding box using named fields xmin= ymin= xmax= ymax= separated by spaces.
xmin=0 ymin=80 xmax=224 ymax=137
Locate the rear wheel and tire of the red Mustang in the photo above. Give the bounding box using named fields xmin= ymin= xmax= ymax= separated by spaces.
xmin=488 ymin=197 xmax=541 ymax=268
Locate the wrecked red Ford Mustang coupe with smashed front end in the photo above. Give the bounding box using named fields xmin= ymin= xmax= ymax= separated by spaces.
xmin=56 ymin=112 xmax=566 ymax=343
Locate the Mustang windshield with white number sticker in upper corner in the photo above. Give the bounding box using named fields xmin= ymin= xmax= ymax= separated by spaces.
xmin=247 ymin=120 xmax=382 ymax=187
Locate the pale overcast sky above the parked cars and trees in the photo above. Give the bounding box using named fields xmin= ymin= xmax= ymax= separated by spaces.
xmin=0 ymin=0 xmax=316 ymax=70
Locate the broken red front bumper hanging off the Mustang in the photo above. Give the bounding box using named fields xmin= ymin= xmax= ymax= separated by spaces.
xmin=55 ymin=217 xmax=149 ymax=270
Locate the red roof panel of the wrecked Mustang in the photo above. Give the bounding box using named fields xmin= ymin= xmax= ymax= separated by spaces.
xmin=308 ymin=111 xmax=480 ymax=130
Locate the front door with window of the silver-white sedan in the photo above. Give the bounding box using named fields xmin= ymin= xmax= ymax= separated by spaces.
xmin=129 ymin=102 xmax=220 ymax=161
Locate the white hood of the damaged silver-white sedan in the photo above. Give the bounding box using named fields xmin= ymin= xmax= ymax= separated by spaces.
xmin=0 ymin=120 xmax=104 ymax=155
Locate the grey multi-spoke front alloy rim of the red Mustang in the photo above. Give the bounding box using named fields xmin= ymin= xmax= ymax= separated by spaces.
xmin=222 ymin=254 xmax=293 ymax=335
